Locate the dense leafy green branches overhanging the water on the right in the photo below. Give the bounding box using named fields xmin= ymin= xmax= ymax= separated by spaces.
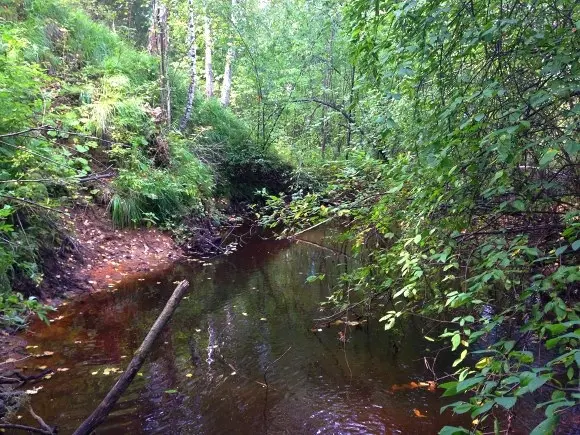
xmin=262 ymin=1 xmax=580 ymax=433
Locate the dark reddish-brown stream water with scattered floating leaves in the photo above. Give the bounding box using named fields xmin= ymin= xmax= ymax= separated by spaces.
xmin=19 ymin=230 xmax=472 ymax=434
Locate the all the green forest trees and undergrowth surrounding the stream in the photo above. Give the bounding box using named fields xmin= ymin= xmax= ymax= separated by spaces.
xmin=0 ymin=0 xmax=580 ymax=434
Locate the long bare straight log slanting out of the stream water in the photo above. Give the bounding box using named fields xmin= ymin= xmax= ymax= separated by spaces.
xmin=73 ymin=280 xmax=189 ymax=435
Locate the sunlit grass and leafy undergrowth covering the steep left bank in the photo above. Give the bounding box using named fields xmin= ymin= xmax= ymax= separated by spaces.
xmin=0 ymin=0 xmax=288 ymax=326
